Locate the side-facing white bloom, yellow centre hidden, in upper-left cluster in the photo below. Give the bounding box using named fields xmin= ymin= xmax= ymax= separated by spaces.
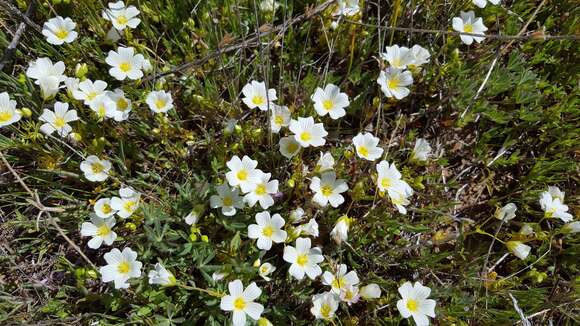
xmin=26 ymin=58 xmax=67 ymax=99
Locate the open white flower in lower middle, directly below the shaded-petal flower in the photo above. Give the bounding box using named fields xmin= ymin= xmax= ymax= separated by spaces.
xmin=283 ymin=238 xmax=324 ymax=280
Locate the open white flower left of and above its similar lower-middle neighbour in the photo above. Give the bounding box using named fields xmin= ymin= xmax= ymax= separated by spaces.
xmin=248 ymin=212 xmax=288 ymax=250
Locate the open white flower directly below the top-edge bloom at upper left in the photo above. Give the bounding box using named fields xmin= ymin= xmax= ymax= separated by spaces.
xmin=105 ymin=47 xmax=145 ymax=80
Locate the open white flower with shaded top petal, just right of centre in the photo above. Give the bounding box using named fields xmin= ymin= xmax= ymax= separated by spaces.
xmin=310 ymin=171 xmax=348 ymax=207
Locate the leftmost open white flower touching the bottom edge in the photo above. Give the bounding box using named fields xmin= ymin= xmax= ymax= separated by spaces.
xmin=220 ymin=280 xmax=264 ymax=326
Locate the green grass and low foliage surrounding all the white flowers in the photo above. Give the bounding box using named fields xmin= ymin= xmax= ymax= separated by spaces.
xmin=0 ymin=0 xmax=580 ymax=325
